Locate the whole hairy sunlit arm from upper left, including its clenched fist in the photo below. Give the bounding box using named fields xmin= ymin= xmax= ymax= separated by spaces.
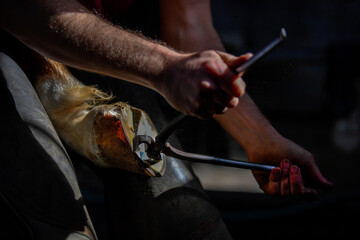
xmin=0 ymin=0 xmax=245 ymax=118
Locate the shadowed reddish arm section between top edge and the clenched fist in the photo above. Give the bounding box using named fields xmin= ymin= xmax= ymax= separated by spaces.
xmin=160 ymin=0 xmax=225 ymax=51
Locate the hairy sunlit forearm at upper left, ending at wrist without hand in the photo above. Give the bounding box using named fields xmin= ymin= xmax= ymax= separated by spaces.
xmin=2 ymin=0 xmax=177 ymax=89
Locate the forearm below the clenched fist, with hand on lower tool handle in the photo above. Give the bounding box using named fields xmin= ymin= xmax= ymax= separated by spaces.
xmin=215 ymin=94 xmax=332 ymax=198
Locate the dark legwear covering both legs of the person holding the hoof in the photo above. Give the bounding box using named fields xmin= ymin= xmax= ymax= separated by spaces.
xmin=0 ymin=53 xmax=231 ymax=239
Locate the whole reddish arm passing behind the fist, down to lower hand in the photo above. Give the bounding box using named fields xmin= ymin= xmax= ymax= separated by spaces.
xmin=161 ymin=0 xmax=332 ymax=198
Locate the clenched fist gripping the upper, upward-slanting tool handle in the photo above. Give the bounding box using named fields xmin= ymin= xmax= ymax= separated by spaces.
xmin=159 ymin=51 xmax=249 ymax=118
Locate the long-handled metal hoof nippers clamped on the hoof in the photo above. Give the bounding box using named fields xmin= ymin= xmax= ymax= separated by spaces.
xmin=133 ymin=28 xmax=286 ymax=171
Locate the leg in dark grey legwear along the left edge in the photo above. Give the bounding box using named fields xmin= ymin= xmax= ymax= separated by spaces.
xmin=0 ymin=53 xmax=95 ymax=239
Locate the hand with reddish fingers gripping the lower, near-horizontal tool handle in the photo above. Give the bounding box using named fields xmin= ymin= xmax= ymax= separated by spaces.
xmin=247 ymin=136 xmax=332 ymax=199
